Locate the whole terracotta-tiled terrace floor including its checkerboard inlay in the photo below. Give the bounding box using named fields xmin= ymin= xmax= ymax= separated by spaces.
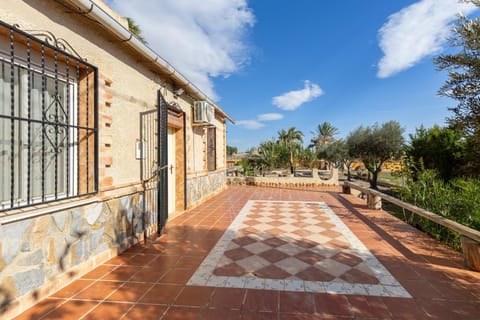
xmin=10 ymin=187 xmax=480 ymax=320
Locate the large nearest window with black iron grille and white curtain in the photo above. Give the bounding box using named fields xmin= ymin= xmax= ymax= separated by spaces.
xmin=0 ymin=24 xmax=97 ymax=211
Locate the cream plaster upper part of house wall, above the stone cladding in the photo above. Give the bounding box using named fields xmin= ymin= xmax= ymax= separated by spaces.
xmin=0 ymin=0 xmax=225 ymax=185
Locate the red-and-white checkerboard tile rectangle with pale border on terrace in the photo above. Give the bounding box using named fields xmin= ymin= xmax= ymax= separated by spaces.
xmin=188 ymin=200 xmax=410 ymax=297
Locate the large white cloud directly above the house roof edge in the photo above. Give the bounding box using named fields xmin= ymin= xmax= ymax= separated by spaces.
xmin=109 ymin=0 xmax=255 ymax=99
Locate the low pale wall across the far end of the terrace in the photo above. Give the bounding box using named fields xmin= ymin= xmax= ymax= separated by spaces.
xmin=227 ymin=169 xmax=339 ymax=189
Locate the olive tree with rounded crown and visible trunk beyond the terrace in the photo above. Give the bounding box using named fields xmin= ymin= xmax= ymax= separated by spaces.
xmin=347 ymin=121 xmax=404 ymax=189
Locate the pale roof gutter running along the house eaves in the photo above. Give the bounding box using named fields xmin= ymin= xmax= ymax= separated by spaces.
xmin=63 ymin=0 xmax=235 ymax=124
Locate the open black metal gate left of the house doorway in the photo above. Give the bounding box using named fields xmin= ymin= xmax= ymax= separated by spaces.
xmin=140 ymin=90 xmax=168 ymax=235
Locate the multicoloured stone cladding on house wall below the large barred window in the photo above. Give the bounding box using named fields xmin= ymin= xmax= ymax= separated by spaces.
xmin=0 ymin=193 xmax=156 ymax=315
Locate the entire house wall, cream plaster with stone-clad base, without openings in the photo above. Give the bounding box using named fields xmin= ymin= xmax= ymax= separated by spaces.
xmin=0 ymin=0 xmax=226 ymax=315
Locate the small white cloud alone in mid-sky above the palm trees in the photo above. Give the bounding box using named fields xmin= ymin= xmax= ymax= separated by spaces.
xmin=272 ymin=80 xmax=323 ymax=111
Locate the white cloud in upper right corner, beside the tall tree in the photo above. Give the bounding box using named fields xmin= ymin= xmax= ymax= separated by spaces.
xmin=377 ymin=0 xmax=476 ymax=78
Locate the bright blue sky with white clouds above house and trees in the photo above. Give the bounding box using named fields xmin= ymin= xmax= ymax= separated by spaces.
xmin=108 ymin=0 xmax=477 ymax=150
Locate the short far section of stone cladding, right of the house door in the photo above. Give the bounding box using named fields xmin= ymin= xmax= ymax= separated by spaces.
xmin=187 ymin=171 xmax=226 ymax=208
